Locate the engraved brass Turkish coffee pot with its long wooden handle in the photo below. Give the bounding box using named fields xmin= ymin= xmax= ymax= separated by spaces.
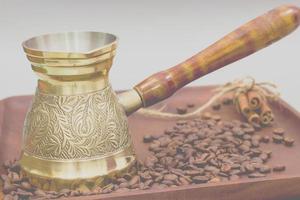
xmin=20 ymin=6 xmax=300 ymax=190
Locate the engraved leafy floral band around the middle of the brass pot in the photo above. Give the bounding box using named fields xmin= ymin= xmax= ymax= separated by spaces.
xmin=24 ymin=87 xmax=130 ymax=160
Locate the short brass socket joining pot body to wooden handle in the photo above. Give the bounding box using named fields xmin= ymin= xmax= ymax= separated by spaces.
xmin=118 ymin=89 xmax=143 ymax=116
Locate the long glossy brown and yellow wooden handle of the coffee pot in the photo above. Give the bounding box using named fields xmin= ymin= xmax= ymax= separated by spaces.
xmin=134 ymin=5 xmax=300 ymax=107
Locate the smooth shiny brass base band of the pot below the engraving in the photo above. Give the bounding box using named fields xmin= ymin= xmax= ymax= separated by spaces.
xmin=20 ymin=146 xmax=136 ymax=191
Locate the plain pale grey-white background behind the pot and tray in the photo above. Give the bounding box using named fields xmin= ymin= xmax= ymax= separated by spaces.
xmin=0 ymin=0 xmax=300 ymax=110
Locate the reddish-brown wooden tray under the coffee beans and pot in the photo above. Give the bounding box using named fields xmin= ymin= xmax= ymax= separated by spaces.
xmin=0 ymin=86 xmax=300 ymax=200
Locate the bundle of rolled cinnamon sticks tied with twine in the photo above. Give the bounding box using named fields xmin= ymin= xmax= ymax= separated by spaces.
xmin=234 ymin=89 xmax=274 ymax=126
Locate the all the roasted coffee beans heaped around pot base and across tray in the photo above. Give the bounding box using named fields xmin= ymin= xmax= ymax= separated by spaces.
xmin=1 ymin=113 xmax=294 ymax=200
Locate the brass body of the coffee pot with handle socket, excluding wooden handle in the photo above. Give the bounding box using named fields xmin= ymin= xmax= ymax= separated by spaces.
xmin=20 ymin=32 xmax=142 ymax=190
